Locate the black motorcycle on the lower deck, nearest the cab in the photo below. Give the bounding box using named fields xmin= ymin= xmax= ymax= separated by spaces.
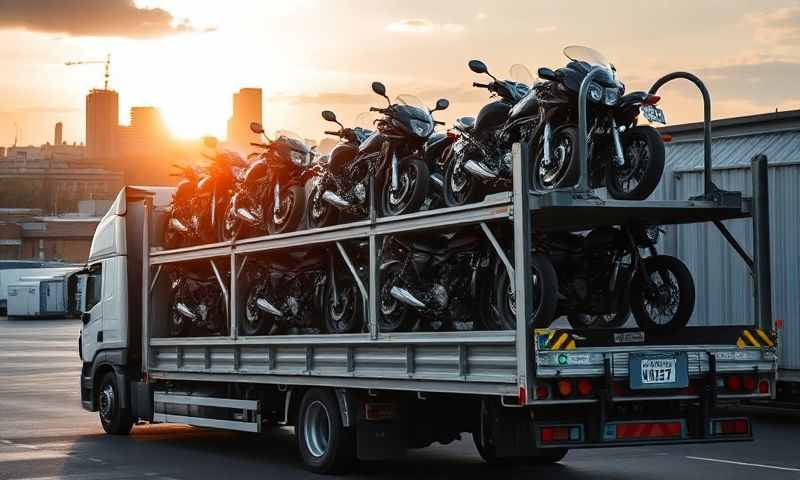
xmin=169 ymin=268 xmax=228 ymax=337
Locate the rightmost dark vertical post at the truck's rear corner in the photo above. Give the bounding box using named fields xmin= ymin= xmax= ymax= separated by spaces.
xmin=750 ymin=155 xmax=772 ymax=331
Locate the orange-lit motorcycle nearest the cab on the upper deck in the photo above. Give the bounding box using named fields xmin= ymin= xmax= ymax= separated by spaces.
xmin=163 ymin=137 xmax=247 ymax=249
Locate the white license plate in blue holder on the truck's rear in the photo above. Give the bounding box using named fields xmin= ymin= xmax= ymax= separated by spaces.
xmin=629 ymin=352 xmax=689 ymax=390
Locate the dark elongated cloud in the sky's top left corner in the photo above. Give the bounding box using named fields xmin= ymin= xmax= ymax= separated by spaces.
xmin=0 ymin=0 xmax=210 ymax=38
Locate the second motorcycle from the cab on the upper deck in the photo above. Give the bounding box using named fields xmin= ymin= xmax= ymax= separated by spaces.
xmin=222 ymin=122 xmax=316 ymax=240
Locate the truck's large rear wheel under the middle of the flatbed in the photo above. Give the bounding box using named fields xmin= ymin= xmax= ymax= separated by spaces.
xmin=295 ymin=388 xmax=356 ymax=474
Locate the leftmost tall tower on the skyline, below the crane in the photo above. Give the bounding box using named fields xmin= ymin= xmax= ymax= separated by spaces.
xmin=86 ymin=89 xmax=119 ymax=160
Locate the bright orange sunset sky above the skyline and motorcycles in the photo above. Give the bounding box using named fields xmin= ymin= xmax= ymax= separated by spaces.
xmin=0 ymin=0 xmax=800 ymax=145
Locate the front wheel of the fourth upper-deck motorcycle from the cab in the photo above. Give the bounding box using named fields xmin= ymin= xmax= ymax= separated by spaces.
xmin=381 ymin=159 xmax=430 ymax=217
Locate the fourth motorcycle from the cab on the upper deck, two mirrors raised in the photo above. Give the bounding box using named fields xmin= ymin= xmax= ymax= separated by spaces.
xmin=368 ymin=82 xmax=450 ymax=216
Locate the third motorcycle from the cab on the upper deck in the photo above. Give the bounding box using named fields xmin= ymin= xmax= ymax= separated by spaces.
xmin=306 ymin=110 xmax=380 ymax=228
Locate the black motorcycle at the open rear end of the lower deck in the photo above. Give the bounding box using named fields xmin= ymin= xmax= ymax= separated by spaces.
xmin=536 ymin=226 xmax=695 ymax=334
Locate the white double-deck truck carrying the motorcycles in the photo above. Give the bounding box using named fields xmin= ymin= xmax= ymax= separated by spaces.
xmin=81 ymin=75 xmax=776 ymax=472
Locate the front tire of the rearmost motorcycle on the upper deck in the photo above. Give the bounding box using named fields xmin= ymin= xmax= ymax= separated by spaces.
xmin=606 ymin=125 xmax=665 ymax=200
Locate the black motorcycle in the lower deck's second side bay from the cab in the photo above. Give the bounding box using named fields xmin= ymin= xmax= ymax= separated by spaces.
xmin=240 ymin=244 xmax=365 ymax=336
